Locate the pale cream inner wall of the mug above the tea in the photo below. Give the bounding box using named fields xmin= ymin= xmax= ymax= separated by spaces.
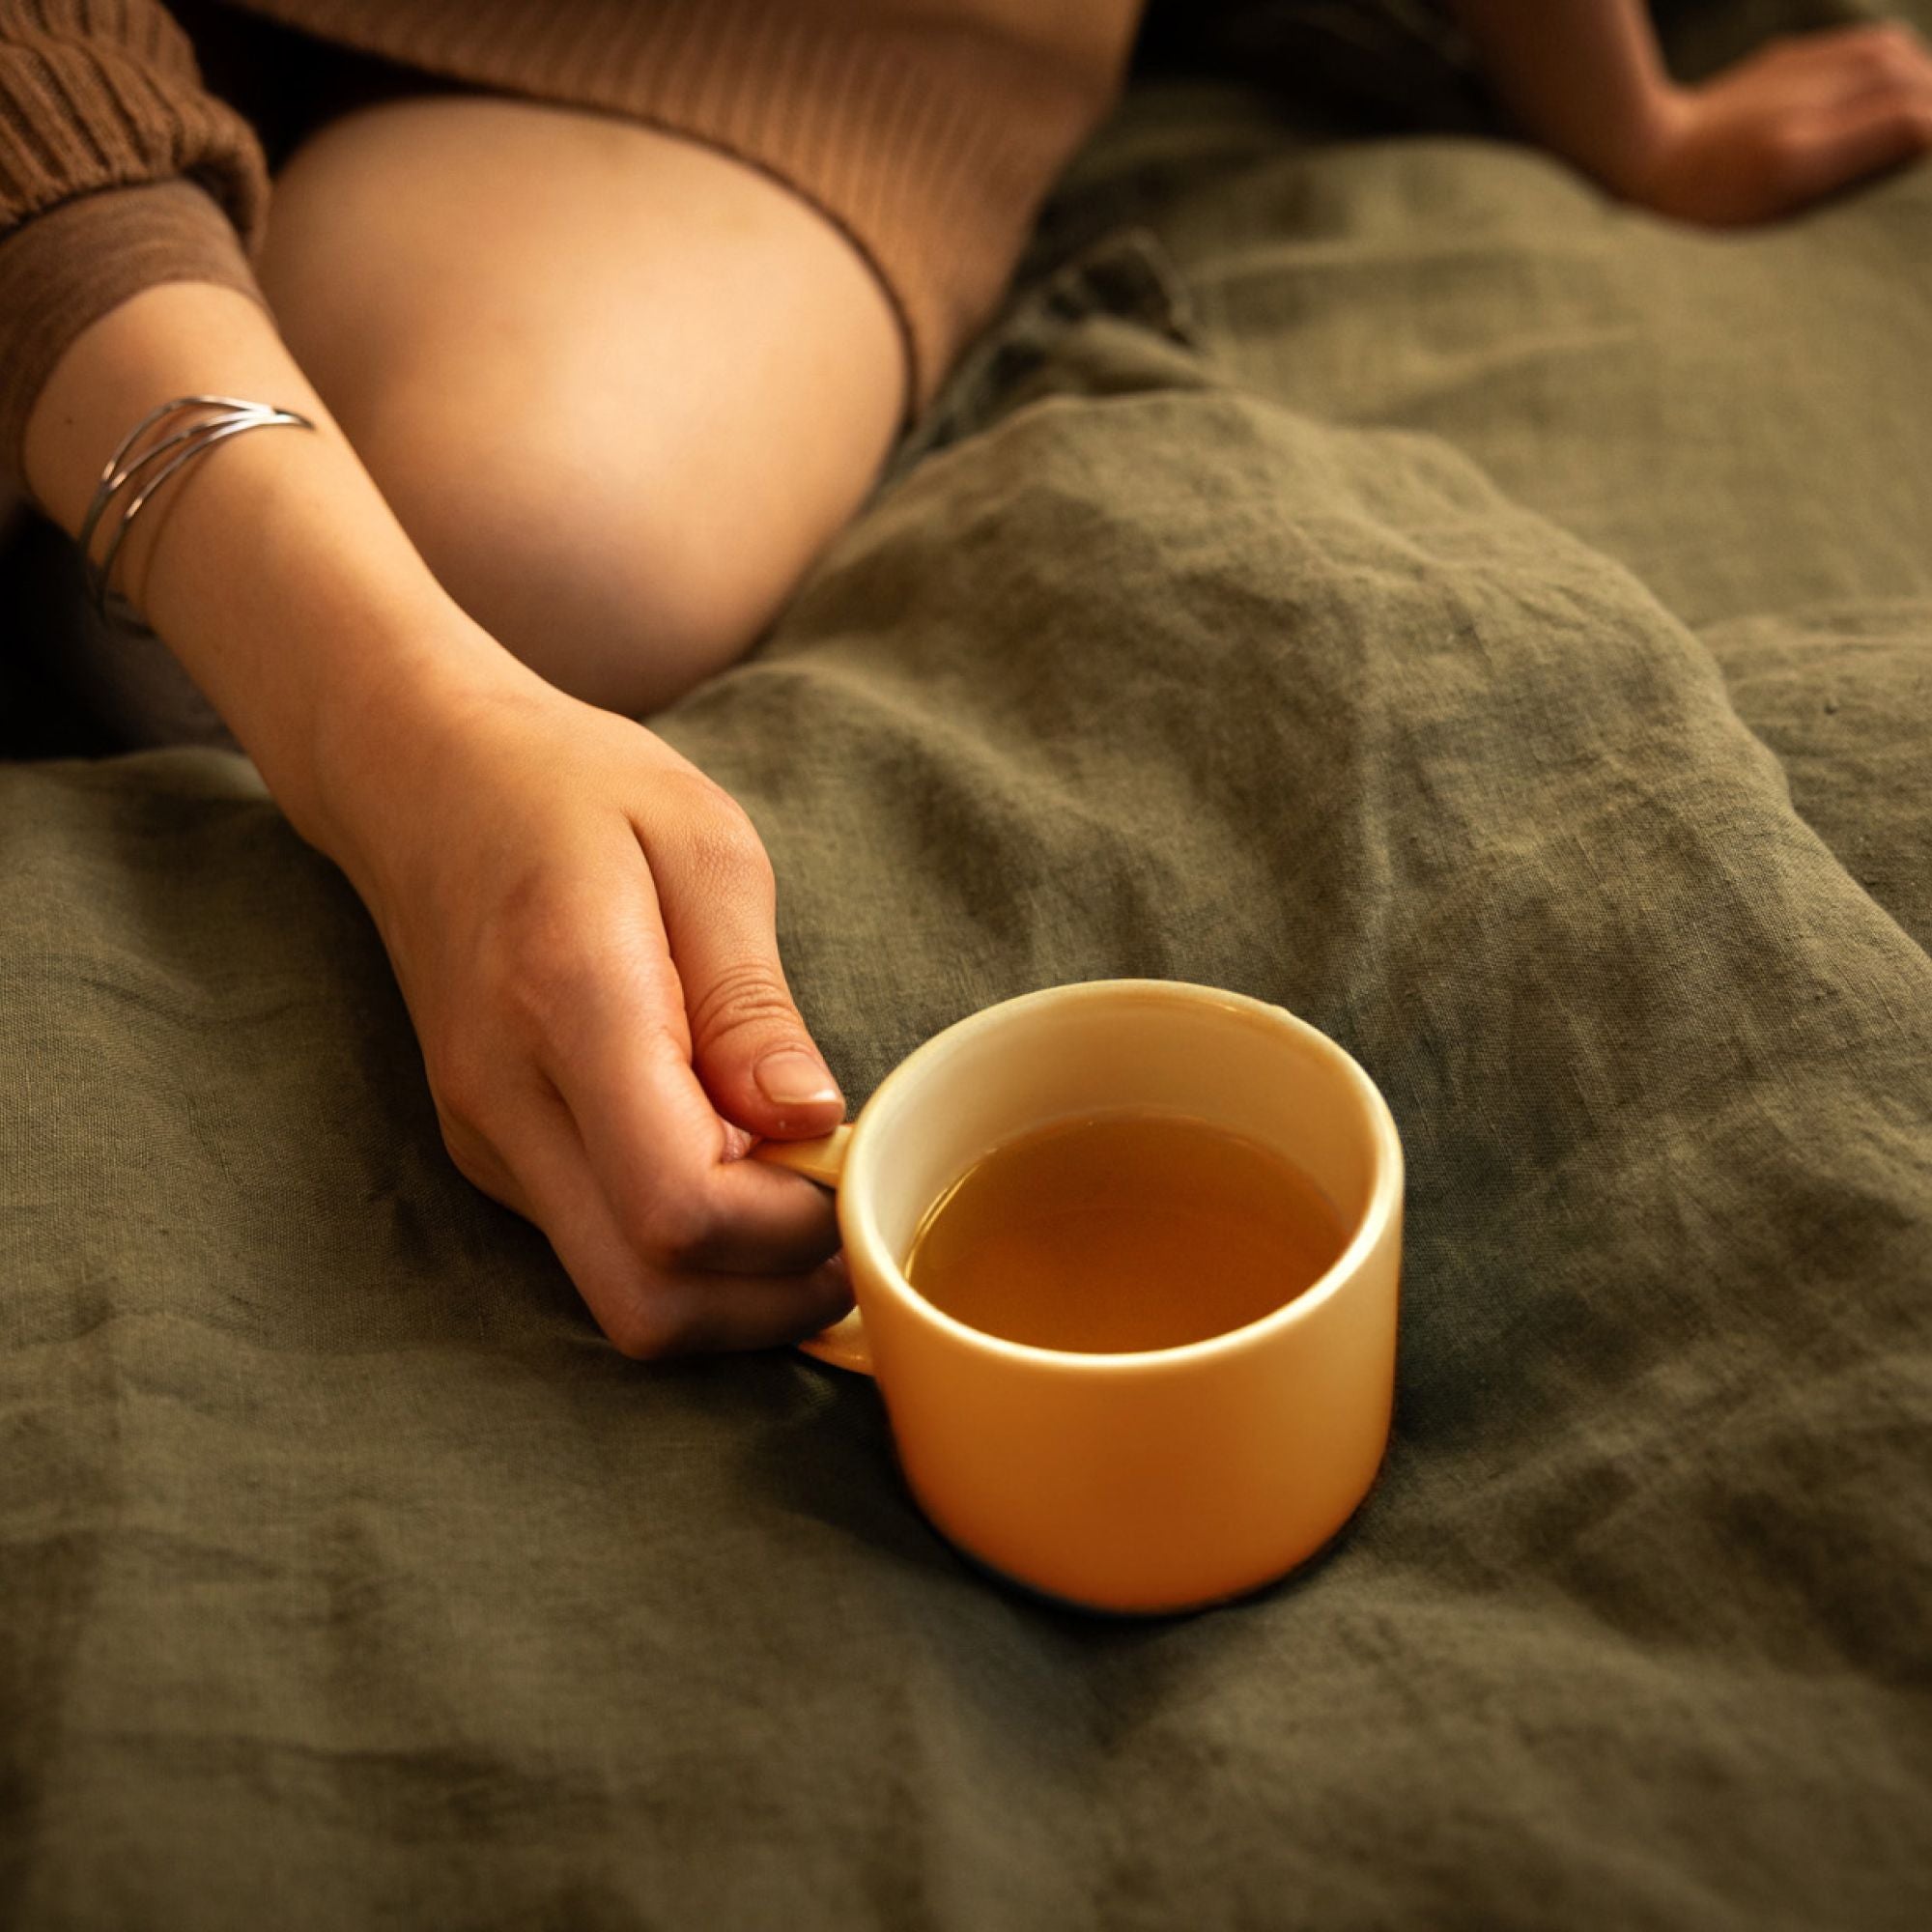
xmin=842 ymin=980 xmax=1399 ymax=1293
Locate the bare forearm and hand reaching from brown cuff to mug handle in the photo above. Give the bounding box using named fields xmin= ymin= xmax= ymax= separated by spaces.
xmin=25 ymin=282 xmax=852 ymax=1356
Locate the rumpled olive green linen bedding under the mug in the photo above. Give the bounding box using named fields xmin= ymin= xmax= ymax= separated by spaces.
xmin=0 ymin=10 xmax=1932 ymax=1932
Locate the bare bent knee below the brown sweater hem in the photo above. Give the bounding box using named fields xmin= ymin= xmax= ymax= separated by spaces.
xmin=259 ymin=97 xmax=904 ymax=715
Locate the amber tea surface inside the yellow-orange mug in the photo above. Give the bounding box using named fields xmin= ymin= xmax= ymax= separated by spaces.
xmin=906 ymin=1113 xmax=1347 ymax=1354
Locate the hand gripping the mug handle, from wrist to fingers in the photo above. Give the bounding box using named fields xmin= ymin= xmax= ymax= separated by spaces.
xmin=328 ymin=667 xmax=852 ymax=1358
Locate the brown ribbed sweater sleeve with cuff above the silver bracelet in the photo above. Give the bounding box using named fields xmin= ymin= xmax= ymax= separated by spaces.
xmin=0 ymin=0 xmax=269 ymax=481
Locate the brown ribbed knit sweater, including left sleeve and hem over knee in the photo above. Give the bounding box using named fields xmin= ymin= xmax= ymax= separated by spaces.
xmin=0 ymin=0 xmax=1138 ymax=495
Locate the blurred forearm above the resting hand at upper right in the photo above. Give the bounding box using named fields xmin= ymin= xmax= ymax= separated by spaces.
xmin=1453 ymin=0 xmax=1671 ymax=182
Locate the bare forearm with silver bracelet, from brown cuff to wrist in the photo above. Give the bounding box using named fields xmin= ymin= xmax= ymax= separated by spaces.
xmin=25 ymin=282 xmax=529 ymax=856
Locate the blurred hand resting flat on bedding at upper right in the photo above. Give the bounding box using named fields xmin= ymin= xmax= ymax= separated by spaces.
xmin=1602 ymin=25 xmax=1932 ymax=226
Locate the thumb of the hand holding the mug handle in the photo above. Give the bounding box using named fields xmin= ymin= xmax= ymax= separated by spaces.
xmin=655 ymin=823 xmax=844 ymax=1140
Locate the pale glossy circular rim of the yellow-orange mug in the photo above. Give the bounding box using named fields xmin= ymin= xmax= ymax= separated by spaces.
xmin=838 ymin=980 xmax=1405 ymax=1374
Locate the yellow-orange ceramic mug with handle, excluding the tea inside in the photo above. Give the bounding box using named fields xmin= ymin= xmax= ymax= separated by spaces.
xmin=757 ymin=980 xmax=1403 ymax=1613
